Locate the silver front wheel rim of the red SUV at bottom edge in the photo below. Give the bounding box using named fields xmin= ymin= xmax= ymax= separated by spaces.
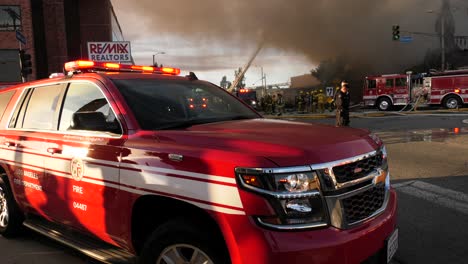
xmin=156 ymin=244 xmax=213 ymax=264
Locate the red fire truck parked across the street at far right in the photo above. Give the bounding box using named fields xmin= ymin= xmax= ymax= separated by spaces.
xmin=363 ymin=70 xmax=468 ymax=111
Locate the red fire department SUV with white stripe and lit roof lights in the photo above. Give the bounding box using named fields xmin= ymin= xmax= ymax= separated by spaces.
xmin=0 ymin=61 xmax=398 ymax=264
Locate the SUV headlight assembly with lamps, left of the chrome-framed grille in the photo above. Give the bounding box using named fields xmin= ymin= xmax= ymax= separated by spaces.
xmin=236 ymin=168 xmax=328 ymax=229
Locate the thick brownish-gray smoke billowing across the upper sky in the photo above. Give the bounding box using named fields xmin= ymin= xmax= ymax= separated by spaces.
xmin=113 ymin=0 xmax=450 ymax=71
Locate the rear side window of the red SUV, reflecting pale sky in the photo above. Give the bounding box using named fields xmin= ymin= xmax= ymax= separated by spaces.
xmin=10 ymin=84 xmax=63 ymax=130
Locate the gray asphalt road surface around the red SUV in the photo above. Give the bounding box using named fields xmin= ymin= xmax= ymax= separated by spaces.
xmin=0 ymin=114 xmax=468 ymax=264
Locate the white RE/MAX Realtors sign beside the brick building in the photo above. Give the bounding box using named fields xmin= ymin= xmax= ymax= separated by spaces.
xmin=88 ymin=41 xmax=132 ymax=63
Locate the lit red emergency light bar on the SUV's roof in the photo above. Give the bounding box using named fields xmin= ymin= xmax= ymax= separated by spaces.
xmin=65 ymin=60 xmax=180 ymax=75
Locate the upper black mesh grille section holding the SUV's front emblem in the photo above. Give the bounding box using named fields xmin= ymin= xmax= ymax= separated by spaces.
xmin=333 ymin=153 xmax=382 ymax=183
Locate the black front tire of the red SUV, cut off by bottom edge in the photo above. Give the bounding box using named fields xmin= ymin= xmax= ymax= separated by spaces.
xmin=138 ymin=219 xmax=230 ymax=264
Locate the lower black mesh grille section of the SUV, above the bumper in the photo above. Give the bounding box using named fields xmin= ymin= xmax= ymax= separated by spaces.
xmin=342 ymin=184 xmax=385 ymax=224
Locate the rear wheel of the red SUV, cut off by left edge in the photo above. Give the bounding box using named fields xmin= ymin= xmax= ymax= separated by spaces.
xmin=0 ymin=175 xmax=24 ymax=238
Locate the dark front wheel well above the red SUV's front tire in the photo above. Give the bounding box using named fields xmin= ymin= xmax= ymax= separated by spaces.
xmin=132 ymin=196 xmax=227 ymax=255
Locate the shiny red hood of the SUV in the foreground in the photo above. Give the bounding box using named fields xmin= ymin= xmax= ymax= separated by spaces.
xmin=156 ymin=119 xmax=378 ymax=167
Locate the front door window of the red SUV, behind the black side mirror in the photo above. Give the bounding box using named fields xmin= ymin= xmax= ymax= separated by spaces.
xmin=59 ymin=82 xmax=122 ymax=134
